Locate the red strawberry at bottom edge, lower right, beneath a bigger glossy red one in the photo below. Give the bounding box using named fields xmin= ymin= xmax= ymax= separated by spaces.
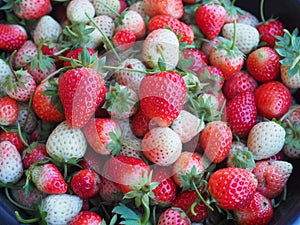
xmin=233 ymin=191 xmax=274 ymax=225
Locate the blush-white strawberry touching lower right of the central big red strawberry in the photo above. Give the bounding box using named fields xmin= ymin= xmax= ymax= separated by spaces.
xmin=171 ymin=110 xmax=204 ymax=143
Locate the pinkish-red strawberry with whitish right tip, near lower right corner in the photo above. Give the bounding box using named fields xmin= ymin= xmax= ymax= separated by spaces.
xmin=252 ymin=160 xmax=293 ymax=198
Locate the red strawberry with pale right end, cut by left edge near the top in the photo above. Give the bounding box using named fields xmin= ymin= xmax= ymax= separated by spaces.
xmin=0 ymin=24 xmax=27 ymax=51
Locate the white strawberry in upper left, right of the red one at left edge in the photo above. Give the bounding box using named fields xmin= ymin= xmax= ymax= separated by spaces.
xmin=33 ymin=15 xmax=62 ymax=45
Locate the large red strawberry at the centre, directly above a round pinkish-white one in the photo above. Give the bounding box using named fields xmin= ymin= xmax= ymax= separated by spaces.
xmin=140 ymin=71 xmax=186 ymax=127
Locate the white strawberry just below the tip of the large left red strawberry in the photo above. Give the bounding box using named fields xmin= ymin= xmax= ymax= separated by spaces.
xmin=46 ymin=121 xmax=87 ymax=163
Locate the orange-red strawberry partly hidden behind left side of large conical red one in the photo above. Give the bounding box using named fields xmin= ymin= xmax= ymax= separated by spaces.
xmin=32 ymin=78 xmax=65 ymax=122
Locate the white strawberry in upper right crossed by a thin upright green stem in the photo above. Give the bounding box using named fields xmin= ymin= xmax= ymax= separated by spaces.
xmin=222 ymin=23 xmax=259 ymax=54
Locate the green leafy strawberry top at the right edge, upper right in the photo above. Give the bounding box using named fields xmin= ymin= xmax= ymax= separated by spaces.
xmin=275 ymin=28 xmax=300 ymax=76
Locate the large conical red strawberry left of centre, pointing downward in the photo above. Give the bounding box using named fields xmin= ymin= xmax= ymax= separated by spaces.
xmin=58 ymin=68 xmax=106 ymax=129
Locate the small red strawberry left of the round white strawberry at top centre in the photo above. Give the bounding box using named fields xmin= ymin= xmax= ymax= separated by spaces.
xmin=112 ymin=30 xmax=136 ymax=51
